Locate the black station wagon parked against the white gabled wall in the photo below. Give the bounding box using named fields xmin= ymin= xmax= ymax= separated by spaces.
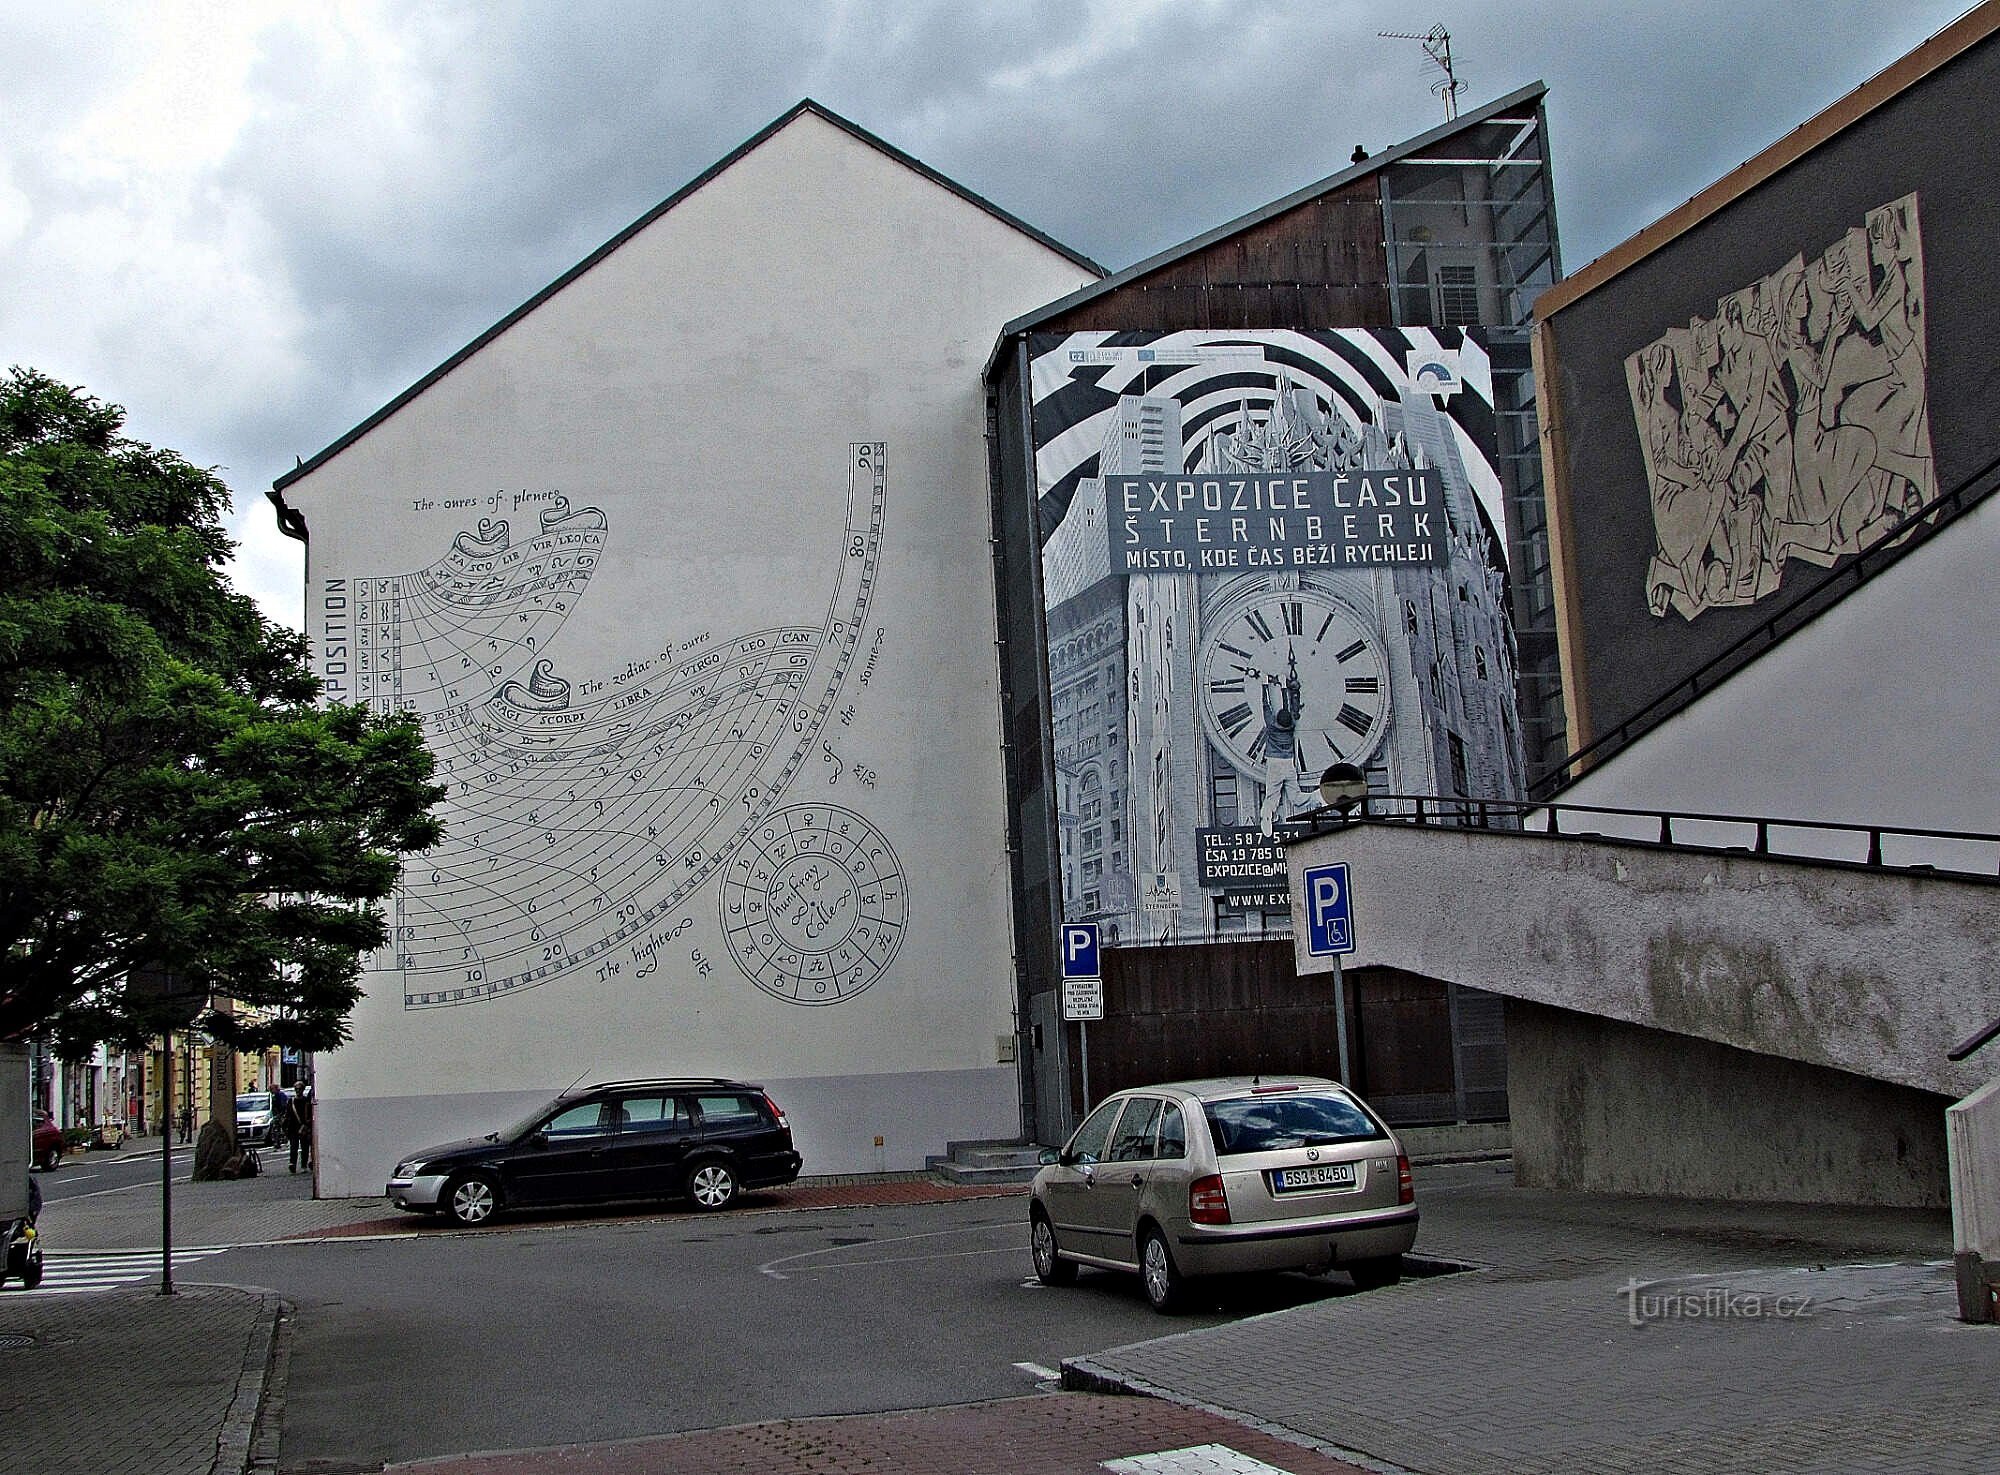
xmin=386 ymin=1077 xmax=804 ymax=1225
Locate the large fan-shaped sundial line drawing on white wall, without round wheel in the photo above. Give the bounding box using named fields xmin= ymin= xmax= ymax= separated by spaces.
xmin=366 ymin=442 xmax=884 ymax=1009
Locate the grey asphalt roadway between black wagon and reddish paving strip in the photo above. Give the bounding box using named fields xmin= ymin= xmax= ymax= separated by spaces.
xmin=198 ymin=1199 xmax=1350 ymax=1475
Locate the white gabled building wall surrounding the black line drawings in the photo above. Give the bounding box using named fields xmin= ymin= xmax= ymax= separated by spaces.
xmin=286 ymin=112 xmax=1090 ymax=1193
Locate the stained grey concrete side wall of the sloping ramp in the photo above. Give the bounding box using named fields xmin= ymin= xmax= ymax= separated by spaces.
xmin=1290 ymin=821 xmax=2000 ymax=1097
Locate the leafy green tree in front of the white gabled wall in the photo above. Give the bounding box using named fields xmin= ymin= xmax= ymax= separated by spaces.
xmin=0 ymin=368 xmax=444 ymax=1051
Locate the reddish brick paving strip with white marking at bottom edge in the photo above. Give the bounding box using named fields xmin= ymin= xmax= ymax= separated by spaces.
xmin=376 ymin=1393 xmax=1362 ymax=1475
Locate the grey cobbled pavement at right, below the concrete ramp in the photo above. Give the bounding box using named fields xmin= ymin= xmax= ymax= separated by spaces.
xmin=1064 ymin=1169 xmax=1976 ymax=1475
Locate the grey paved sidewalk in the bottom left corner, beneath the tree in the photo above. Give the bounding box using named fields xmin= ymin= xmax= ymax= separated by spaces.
xmin=0 ymin=1285 xmax=280 ymax=1475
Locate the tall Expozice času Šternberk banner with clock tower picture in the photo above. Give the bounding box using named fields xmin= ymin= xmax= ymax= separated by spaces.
xmin=1030 ymin=328 xmax=1524 ymax=943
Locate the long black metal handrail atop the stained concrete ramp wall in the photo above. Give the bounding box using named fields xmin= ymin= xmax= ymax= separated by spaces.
xmin=1292 ymin=793 xmax=2000 ymax=879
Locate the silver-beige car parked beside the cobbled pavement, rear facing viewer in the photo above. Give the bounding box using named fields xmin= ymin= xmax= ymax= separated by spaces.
xmin=1028 ymin=1075 xmax=1416 ymax=1311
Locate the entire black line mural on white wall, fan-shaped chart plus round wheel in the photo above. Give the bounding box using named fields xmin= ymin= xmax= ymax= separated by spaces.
xmin=338 ymin=442 xmax=908 ymax=1009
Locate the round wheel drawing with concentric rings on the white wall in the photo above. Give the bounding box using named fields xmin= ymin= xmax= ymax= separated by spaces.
xmin=718 ymin=803 xmax=910 ymax=1005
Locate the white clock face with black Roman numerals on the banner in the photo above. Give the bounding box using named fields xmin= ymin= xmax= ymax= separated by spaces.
xmin=1194 ymin=580 xmax=1388 ymax=783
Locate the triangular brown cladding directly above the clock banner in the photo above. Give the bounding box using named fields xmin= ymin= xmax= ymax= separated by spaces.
xmin=1038 ymin=176 xmax=1390 ymax=332
